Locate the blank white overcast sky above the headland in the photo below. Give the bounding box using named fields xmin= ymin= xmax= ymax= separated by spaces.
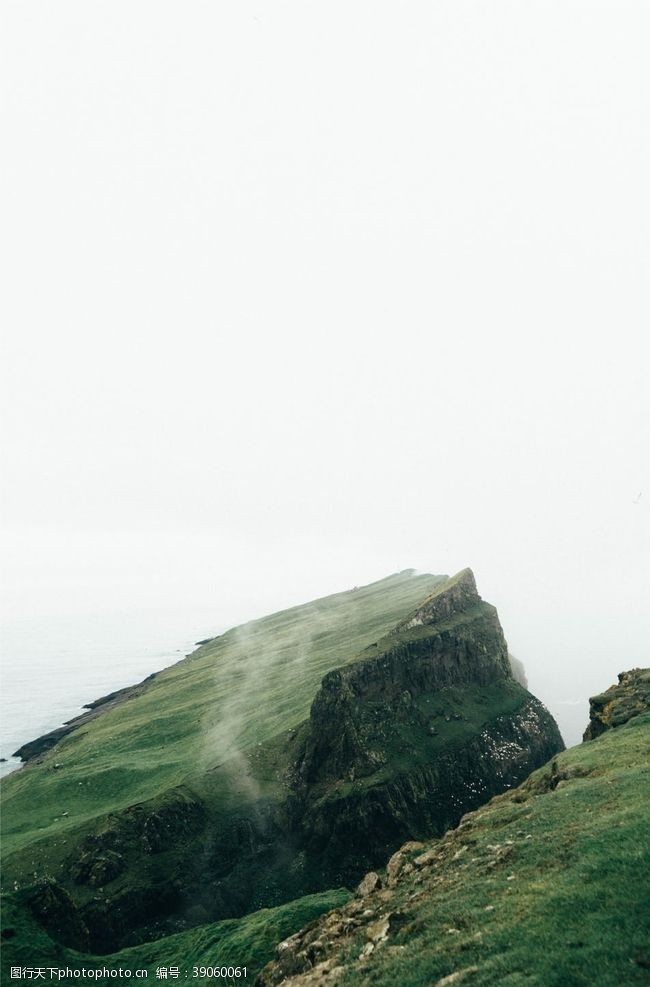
xmin=0 ymin=0 xmax=650 ymax=724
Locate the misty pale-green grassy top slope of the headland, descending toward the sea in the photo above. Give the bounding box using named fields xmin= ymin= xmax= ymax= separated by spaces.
xmin=2 ymin=571 xmax=442 ymax=872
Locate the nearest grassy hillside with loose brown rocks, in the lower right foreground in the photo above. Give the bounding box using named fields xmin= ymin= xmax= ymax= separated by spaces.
xmin=259 ymin=669 xmax=650 ymax=987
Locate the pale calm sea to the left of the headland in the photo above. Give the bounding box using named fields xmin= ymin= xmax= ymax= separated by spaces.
xmin=0 ymin=610 xmax=224 ymax=775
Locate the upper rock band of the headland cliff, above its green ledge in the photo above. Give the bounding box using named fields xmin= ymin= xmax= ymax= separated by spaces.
xmin=297 ymin=569 xmax=512 ymax=784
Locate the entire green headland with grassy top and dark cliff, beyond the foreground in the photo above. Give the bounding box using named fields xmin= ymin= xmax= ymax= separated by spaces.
xmin=3 ymin=570 xmax=563 ymax=953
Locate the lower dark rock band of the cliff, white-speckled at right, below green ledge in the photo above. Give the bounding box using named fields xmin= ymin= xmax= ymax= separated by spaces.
xmin=284 ymin=697 xmax=563 ymax=886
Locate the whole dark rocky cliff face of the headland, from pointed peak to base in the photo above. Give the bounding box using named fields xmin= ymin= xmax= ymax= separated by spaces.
xmin=289 ymin=570 xmax=564 ymax=883
